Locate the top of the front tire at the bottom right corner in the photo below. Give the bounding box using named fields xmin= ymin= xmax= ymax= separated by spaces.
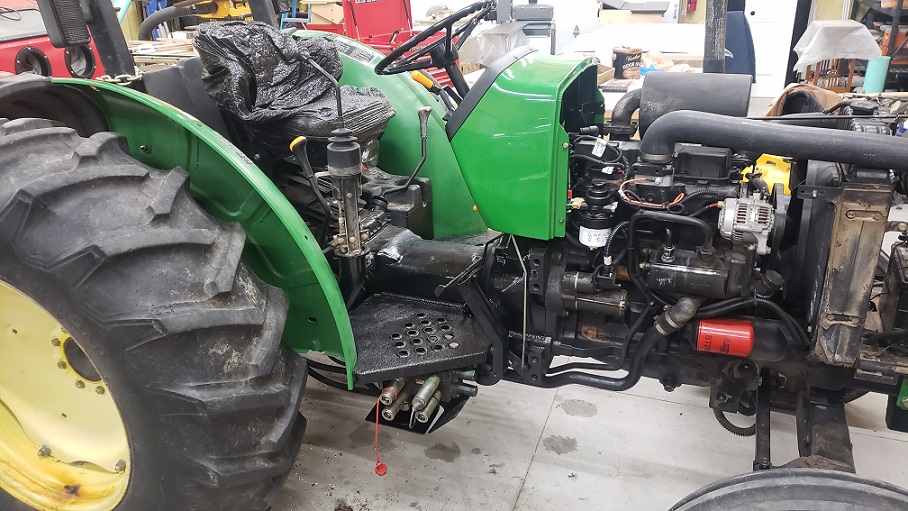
xmin=671 ymin=468 xmax=908 ymax=511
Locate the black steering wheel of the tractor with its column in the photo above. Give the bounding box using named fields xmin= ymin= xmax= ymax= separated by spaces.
xmin=375 ymin=0 xmax=495 ymax=96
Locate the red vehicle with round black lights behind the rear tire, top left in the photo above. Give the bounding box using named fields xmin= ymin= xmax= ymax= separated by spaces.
xmin=0 ymin=0 xmax=104 ymax=78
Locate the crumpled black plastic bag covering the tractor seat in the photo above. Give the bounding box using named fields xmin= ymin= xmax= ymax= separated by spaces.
xmin=195 ymin=21 xmax=394 ymax=154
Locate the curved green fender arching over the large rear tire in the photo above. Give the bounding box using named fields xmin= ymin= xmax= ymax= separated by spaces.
xmin=48 ymin=79 xmax=356 ymax=385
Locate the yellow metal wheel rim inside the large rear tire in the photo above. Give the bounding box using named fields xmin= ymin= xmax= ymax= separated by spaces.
xmin=0 ymin=281 xmax=130 ymax=511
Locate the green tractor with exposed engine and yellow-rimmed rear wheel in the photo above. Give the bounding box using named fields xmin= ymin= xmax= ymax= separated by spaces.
xmin=0 ymin=0 xmax=908 ymax=511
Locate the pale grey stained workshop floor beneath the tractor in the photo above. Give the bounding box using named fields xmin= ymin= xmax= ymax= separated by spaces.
xmin=273 ymin=372 xmax=908 ymax=511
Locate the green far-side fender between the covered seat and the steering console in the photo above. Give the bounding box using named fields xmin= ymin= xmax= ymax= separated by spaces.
xmin=294 ymin=30 xmax=486 ymax=236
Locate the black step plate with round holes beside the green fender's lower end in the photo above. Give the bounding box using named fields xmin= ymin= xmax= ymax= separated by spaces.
xmin=350 ymin=294 xmax=491 ymax=383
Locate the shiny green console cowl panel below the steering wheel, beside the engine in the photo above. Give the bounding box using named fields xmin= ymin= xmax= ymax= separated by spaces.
xmin=451 ymin=52 xmax=601 ymax=240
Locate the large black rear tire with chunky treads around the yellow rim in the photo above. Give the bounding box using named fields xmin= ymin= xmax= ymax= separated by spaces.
xmin=0 ymin=119 xmax=306 ymax=511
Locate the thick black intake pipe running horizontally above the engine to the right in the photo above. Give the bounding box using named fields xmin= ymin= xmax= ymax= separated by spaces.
xmin=640 ymin=110 xmax=908 ymax=172
